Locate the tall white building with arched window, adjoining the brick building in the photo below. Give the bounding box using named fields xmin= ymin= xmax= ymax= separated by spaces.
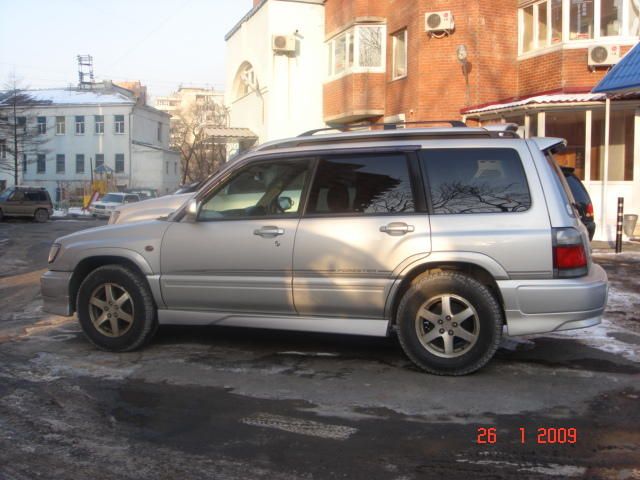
xmin=225 ymin=0 xmax=326 ymax=142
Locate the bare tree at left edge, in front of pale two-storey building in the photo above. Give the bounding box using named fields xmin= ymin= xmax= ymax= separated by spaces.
xmin=0 ymin=75 xmax=47 ymax=185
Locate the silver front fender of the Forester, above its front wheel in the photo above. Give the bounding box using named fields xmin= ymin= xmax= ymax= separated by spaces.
xmin=49 ymin=220 xmax=170 ymax=275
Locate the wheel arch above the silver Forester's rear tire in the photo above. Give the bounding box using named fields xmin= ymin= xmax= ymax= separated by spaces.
xmin=385 ymin=259 xmax=508 ymax=325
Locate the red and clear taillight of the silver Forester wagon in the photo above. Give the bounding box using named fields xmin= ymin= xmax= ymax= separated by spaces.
xmin=553 ymin=228 xmax=589 ymax=278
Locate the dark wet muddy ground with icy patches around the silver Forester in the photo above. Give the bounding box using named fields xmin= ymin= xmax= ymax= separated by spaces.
xmin=0 ymin=220 xmax=640 ymax=480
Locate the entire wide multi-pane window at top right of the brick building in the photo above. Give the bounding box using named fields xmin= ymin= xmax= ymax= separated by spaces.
xmin=519 ymin=0 xmax=640 ymax=53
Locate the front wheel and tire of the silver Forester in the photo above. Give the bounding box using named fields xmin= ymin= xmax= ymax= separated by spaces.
xmin=76 ymin=265 xmax=158 ymax=352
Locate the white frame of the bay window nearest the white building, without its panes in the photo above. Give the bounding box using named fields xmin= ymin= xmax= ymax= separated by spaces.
xmin=326 ymin=23 xmax=387 ymax=81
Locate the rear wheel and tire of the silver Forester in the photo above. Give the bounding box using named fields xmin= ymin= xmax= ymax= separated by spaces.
xmin=397 ymin=271 xmax=504 ymax=375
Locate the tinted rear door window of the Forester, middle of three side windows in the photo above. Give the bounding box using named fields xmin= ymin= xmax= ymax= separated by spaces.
xmin=307 ymin=153 xmax=415 ymax=215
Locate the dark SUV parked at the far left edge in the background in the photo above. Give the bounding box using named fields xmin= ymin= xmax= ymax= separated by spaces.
xmin=0 ymin=186 xmax=53 ymax=222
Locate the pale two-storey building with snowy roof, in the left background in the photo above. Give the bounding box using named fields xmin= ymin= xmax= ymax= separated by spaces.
xmin=0 ymin=83 xmax=180 ymax=201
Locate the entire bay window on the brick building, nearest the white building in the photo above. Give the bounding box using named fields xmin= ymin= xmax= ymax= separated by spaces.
xmin=327 ymin=25 xmax=386 ymax=76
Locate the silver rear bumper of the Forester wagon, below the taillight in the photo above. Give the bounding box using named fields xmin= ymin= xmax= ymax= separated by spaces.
xmin=498 ymin=264 xmax=609 ymax=335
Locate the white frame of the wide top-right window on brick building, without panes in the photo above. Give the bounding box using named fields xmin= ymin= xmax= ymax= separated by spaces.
xmin=518 ymin=0 xmax=638 ymax=58
